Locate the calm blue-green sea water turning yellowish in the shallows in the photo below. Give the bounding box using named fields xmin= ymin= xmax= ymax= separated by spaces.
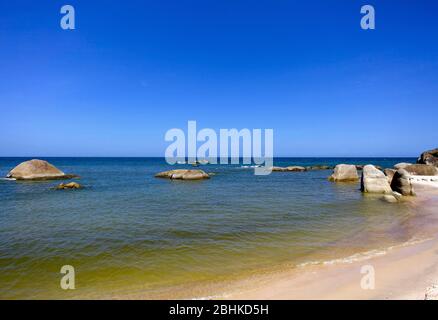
xmin=0 ymin=158 xmax=428 ymax=299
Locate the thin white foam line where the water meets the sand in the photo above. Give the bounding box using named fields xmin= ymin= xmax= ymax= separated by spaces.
xmin=296 ymin=238 xmax=433 ymax=268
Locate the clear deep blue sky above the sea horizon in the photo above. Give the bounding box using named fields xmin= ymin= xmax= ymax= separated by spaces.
xmin=0 ymin=0 xmax=438 ymax=156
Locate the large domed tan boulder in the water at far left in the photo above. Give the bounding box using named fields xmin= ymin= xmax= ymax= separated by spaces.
xmin=6 ymin=159 xmax=77 ymax=180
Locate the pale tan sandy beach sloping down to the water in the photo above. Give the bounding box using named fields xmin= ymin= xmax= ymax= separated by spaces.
xmin=226 ymin=193 xmax=438 ymax=300
